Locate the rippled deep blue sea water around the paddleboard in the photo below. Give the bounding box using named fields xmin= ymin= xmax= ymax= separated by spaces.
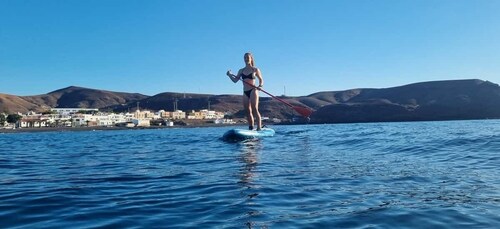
xmin=0 ymin=120 xmax=500 ymax=228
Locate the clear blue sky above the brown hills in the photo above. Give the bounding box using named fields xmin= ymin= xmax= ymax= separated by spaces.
xmin=0 ymin=0 xmax=500 ymax=96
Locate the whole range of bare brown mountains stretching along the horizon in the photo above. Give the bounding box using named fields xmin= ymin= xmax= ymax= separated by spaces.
xmin=0 ymin=79 xmax=500 ymax=123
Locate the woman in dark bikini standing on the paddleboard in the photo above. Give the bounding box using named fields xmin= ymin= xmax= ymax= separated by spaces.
xmin=226 ymin=53 xmax=264 ymax=131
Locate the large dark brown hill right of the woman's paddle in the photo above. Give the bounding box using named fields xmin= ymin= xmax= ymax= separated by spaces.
xmin=311 ymin=80 xmax=500 ymax=123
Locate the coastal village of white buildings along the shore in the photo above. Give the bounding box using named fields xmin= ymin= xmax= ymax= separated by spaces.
xmin=0 ymin=108 xmax=266 ymax=129
